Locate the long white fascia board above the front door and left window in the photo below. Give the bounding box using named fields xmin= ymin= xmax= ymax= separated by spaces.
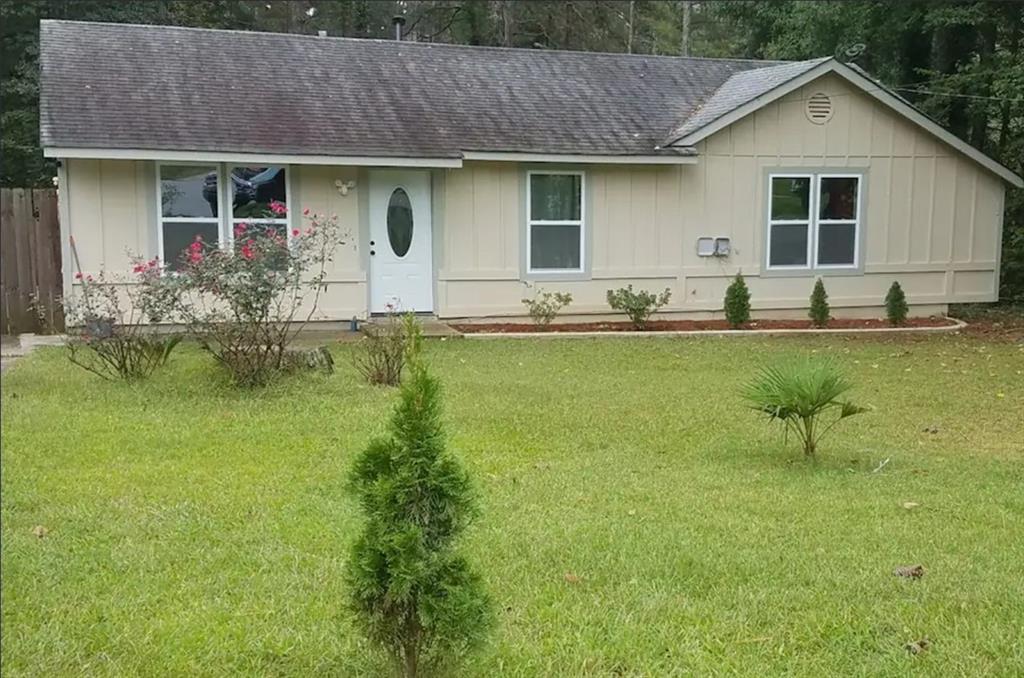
xmin=43 ymin=146 xmax=462 ymax=168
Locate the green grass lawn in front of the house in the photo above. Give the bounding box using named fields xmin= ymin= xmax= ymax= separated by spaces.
xmin=2 ymin=335 xmax=1024 ymax=677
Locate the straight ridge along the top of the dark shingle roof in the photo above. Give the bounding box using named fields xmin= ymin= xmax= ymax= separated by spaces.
xmin=40 ymin=18 xmax=790 ymax=65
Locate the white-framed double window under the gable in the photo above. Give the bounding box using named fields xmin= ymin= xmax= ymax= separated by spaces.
xmin=767 ymin=173 xmax=861 ymax=270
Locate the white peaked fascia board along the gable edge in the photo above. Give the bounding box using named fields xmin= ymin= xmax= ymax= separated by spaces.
xmin=672 ymin=59 xmax=1024 ymax=188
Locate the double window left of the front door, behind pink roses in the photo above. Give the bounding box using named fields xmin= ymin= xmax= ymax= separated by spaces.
xmin=157 ymin=163 xmax=290 ymax=270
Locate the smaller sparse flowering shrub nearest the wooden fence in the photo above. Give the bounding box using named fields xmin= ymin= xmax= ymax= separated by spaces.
xmin=65 ymin=259 xmax=181 ymax=380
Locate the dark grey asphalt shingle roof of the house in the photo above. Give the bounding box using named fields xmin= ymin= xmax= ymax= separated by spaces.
xmin=40 ymin=20 xmax=798 ymax=158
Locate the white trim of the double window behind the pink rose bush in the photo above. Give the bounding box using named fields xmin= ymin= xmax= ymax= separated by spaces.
xmin=155 ymin=160 xmax=294 ymax=268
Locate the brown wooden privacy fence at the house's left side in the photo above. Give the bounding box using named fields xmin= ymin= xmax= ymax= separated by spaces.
xmin=0 ymin=188 xmax=63 ymax=334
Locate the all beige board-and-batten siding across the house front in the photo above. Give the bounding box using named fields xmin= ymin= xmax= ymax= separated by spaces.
xmin=61 ymin=75 xmax=1004 ymax=320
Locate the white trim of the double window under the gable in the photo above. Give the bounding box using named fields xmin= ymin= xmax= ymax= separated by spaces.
xmin=765 ymin=172 xmax=864 ymax=271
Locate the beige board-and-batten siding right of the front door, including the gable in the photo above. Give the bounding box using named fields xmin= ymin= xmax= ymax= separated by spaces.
xmin=437 ymin=75 xmax=1005 ymax=316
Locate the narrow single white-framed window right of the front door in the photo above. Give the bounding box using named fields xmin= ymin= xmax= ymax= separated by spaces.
xmin=526 ymin=171 xmax=584 ymax=272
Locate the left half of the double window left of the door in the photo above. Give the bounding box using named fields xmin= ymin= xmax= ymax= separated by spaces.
xmin=158 ymin=165 xmax=222 ymax=270
